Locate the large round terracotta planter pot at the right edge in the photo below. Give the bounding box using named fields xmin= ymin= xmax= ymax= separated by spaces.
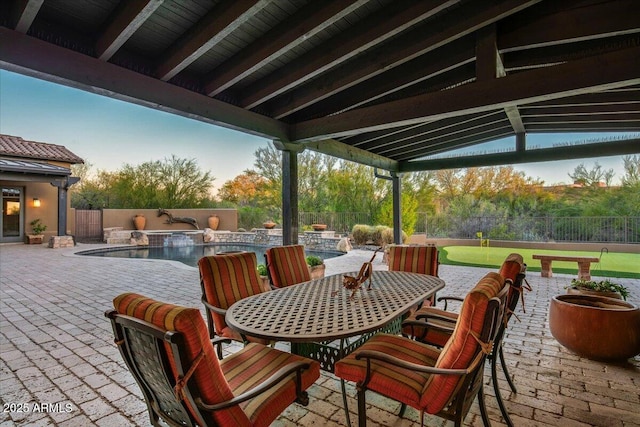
xmin=549 ymin=294 xmax=640 ymax=360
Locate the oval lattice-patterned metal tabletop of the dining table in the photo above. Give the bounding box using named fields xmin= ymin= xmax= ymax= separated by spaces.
xmin=226 ymin=271 xmax=444 ymax=342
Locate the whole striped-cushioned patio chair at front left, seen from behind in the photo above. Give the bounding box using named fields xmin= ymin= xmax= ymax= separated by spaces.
xmin=105 ymin=293 xmax=320 ymax=426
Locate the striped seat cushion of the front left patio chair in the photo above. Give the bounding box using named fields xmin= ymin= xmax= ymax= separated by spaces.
xmin=220 ymin=344 xmax=320 ymax=426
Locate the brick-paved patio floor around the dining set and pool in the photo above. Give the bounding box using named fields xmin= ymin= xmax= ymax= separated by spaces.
xmin=0 ymin=244 xmax=640 ymax=427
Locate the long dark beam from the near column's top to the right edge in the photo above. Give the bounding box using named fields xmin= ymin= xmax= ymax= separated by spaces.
xmin=291 ymin=47 xmax=640 ymax=141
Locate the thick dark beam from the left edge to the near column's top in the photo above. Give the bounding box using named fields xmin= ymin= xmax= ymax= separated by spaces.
xmin=0 ymin=27 xmax=288 ymax=140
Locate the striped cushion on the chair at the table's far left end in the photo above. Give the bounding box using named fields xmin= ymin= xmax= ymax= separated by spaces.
xmin=198 ymin=252 xmax=262 ymax=337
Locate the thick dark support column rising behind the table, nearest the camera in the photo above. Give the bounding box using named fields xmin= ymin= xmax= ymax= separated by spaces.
xmin=273 ymin=140 xmax=304 ymax=245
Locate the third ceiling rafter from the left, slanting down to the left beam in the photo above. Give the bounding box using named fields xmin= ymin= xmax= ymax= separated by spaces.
xmin=156 ymin=0 xmax=273 ymax=81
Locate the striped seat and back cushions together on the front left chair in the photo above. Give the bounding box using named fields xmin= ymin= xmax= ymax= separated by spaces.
xmin=114 ymin=293 xmax=320 ymax=426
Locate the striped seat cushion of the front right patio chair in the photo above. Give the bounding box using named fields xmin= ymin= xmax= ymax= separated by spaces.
xmin=335 ymin=334 xmax=440 ymax=408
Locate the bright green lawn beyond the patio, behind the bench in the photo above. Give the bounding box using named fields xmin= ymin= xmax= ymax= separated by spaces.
xmin=439 ymin=246 xmax=640 ymax=279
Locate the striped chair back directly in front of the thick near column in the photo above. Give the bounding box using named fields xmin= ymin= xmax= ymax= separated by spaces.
xmin=264 ymin=245 xmax=311 ymax=288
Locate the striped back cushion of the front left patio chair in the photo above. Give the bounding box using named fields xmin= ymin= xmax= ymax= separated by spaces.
xmin=113 ymin=293 xmax=250 ymax=426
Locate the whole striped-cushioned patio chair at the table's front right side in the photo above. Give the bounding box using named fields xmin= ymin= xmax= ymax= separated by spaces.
xmin=335 ymin=272 xmax=508 ymax=426
